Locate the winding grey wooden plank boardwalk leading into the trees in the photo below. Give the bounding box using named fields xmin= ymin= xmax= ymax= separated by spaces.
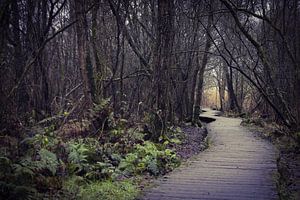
xmin=143 ymin=110 xmax=278 ymax=200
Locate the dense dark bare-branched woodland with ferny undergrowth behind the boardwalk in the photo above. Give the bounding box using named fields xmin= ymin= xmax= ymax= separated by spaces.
xmin=0 ymin=0 xmax=300 ymax=199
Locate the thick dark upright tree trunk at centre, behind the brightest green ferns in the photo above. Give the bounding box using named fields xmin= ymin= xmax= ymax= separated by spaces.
xmin=152 ymin=0 xmax=174 ymax=139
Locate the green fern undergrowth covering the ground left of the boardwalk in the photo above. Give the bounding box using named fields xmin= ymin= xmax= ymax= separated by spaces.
xmin=0 ymin=100 xmax=182 ymax=200
